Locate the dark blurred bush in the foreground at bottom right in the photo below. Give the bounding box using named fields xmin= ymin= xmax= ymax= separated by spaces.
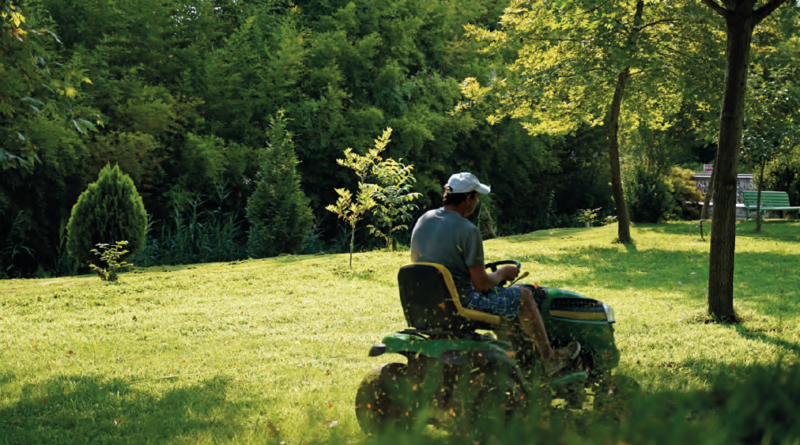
xmin=364 ymin=366 xmax=800 ymax=445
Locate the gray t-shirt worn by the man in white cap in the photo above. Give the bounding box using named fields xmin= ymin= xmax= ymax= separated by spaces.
xmin=411 ymin=208 xmax=484 ymax=295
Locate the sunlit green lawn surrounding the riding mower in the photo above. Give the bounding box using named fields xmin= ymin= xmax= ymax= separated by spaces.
xmin=0 ymin=222 xmax=800 ymax=445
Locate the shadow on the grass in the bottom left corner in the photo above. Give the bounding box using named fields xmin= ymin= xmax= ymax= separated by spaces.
xmin=0 ymin=376 xmax=242 ymax=444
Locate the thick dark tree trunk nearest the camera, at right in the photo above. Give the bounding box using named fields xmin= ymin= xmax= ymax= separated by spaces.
xmin=708 ymin=10 xmax=754 ymax=321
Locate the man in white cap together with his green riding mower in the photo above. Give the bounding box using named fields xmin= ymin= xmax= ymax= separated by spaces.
xmin=356 ymin=173 xmax=632 ymax=432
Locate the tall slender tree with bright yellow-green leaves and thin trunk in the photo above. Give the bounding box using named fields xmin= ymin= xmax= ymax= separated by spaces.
xmin=463 ymin=0 xmax=713 ymax=243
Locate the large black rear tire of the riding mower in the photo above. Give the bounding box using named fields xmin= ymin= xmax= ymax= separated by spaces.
xmin=356 ymin=363 xmax=419 ymax=434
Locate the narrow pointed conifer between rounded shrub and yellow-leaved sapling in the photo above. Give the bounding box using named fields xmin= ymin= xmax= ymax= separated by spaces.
xmin=247 ymin=112 xmax=314 ymax=258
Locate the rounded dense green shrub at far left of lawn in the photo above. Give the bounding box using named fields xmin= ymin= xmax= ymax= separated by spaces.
xmin=67 ymin=165 xmax=147 ymax=264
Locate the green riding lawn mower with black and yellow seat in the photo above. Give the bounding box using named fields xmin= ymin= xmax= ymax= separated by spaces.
xmin=356 ymin=261 xmax=636 ymax=433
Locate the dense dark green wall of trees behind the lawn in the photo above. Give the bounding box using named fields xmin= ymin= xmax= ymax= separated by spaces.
xmin=0 ymin=0 xmax=797 ymax=277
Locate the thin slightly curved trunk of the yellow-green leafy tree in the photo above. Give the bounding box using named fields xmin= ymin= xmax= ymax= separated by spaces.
xmin=606 ymin=0 xmax=644 ymax=244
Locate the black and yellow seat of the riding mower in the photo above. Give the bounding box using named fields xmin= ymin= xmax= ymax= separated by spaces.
xmin=397 ymin=263 xmax=502 ymax=332
